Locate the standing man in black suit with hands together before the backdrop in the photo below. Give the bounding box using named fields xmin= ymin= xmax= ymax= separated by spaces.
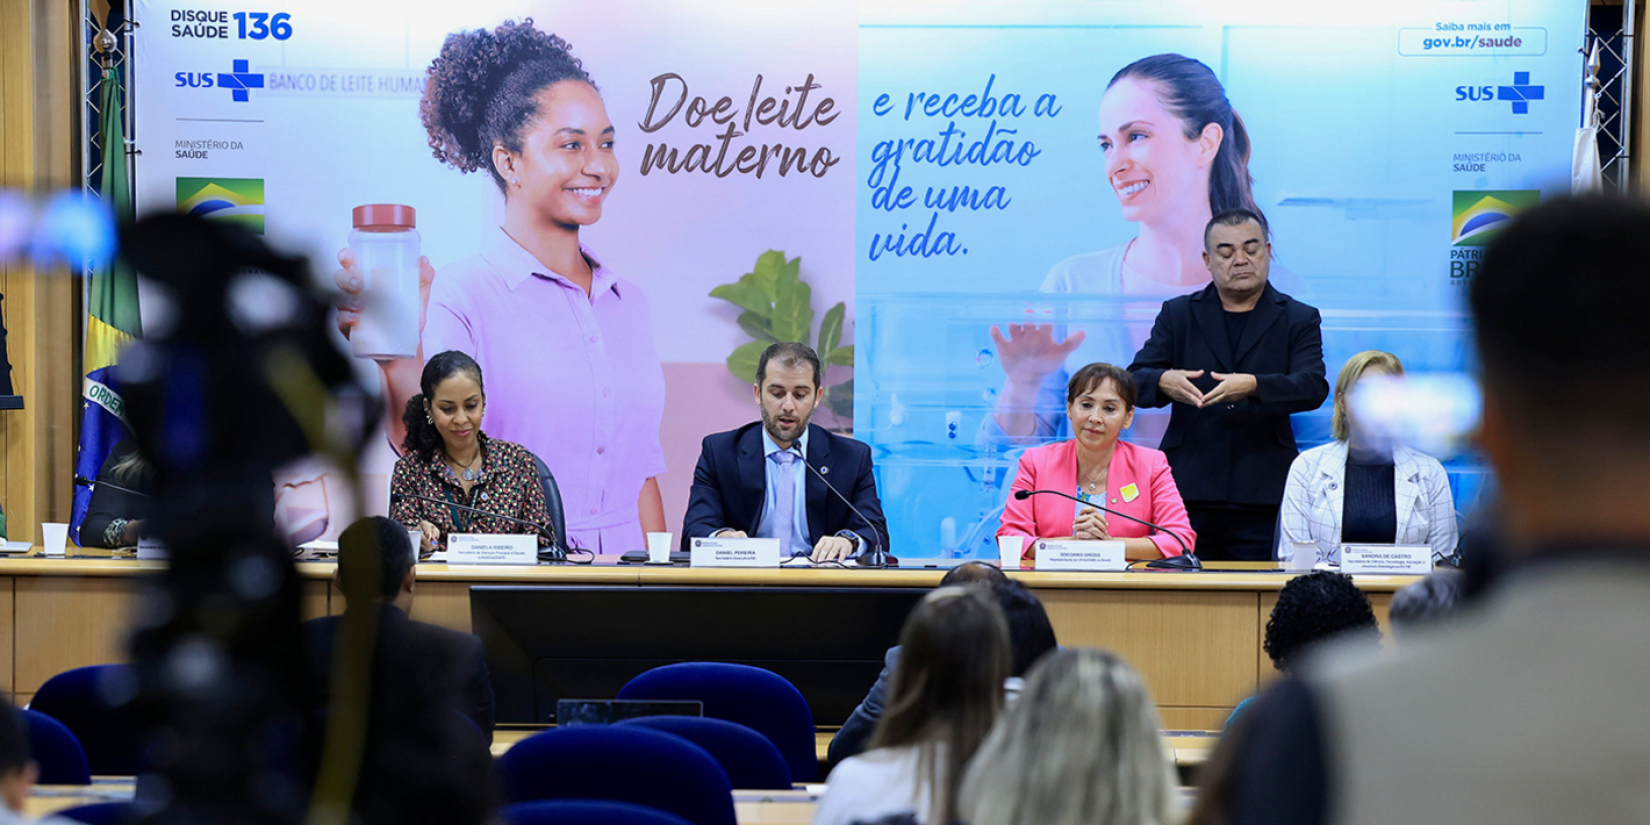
xmin=1129 ymin=210 xmax=1330 ymax=559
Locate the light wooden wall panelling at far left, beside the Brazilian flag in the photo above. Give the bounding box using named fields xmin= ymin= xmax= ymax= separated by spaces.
xmin=0 ymin=0 xmax=79 ymax=540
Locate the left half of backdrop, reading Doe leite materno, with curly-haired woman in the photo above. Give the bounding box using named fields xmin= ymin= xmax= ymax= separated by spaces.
xmin=135 ymin=0 xmax=855 ymax=553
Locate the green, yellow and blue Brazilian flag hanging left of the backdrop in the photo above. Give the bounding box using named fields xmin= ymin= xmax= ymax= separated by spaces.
xmin=69 ymin=66 xmax=142 ymax=543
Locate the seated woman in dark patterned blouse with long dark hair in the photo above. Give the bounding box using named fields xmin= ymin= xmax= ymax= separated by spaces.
xmin=389 ymin=350 xmax=549 ymax=554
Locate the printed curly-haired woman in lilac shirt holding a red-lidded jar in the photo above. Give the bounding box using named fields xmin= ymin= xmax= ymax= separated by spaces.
xmin=335 ymin=18 xmax=667 ymax=553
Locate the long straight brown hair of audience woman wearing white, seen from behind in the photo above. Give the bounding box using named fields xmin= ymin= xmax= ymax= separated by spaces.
xmin=871 ymin=587 xmax=1008 ymax=823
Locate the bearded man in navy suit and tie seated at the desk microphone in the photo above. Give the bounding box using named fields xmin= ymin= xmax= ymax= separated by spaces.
xmin=681 ymin=343 xmax=888 ymax=561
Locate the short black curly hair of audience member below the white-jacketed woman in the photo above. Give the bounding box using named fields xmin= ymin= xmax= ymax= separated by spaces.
xmin=1264 ymin=571 xmax=1381 ymax=673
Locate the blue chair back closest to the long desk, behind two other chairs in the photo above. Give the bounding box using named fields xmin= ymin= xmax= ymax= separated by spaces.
xmin=619 ymin=662 xmax=820 ymax=782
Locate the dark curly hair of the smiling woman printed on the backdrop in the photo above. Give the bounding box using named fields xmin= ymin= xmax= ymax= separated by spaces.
xmin=419 ymin=18 xmax=596 ymax=191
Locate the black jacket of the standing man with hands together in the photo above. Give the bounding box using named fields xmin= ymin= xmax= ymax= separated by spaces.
xmin=1129 ymin=284 xmax=1330 ymax=507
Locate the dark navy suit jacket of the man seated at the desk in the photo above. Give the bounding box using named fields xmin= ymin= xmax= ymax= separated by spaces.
xmin=681 ymin=422 xmax=889 ymax=551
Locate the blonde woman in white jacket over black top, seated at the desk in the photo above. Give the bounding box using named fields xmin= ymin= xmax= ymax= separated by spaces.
xmin=1277 ymin=350 xmax=1457 ymax=563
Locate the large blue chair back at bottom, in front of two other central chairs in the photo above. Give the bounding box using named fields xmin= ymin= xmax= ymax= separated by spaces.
xmin=497 ymin=724 xmax=736 ymax=825
